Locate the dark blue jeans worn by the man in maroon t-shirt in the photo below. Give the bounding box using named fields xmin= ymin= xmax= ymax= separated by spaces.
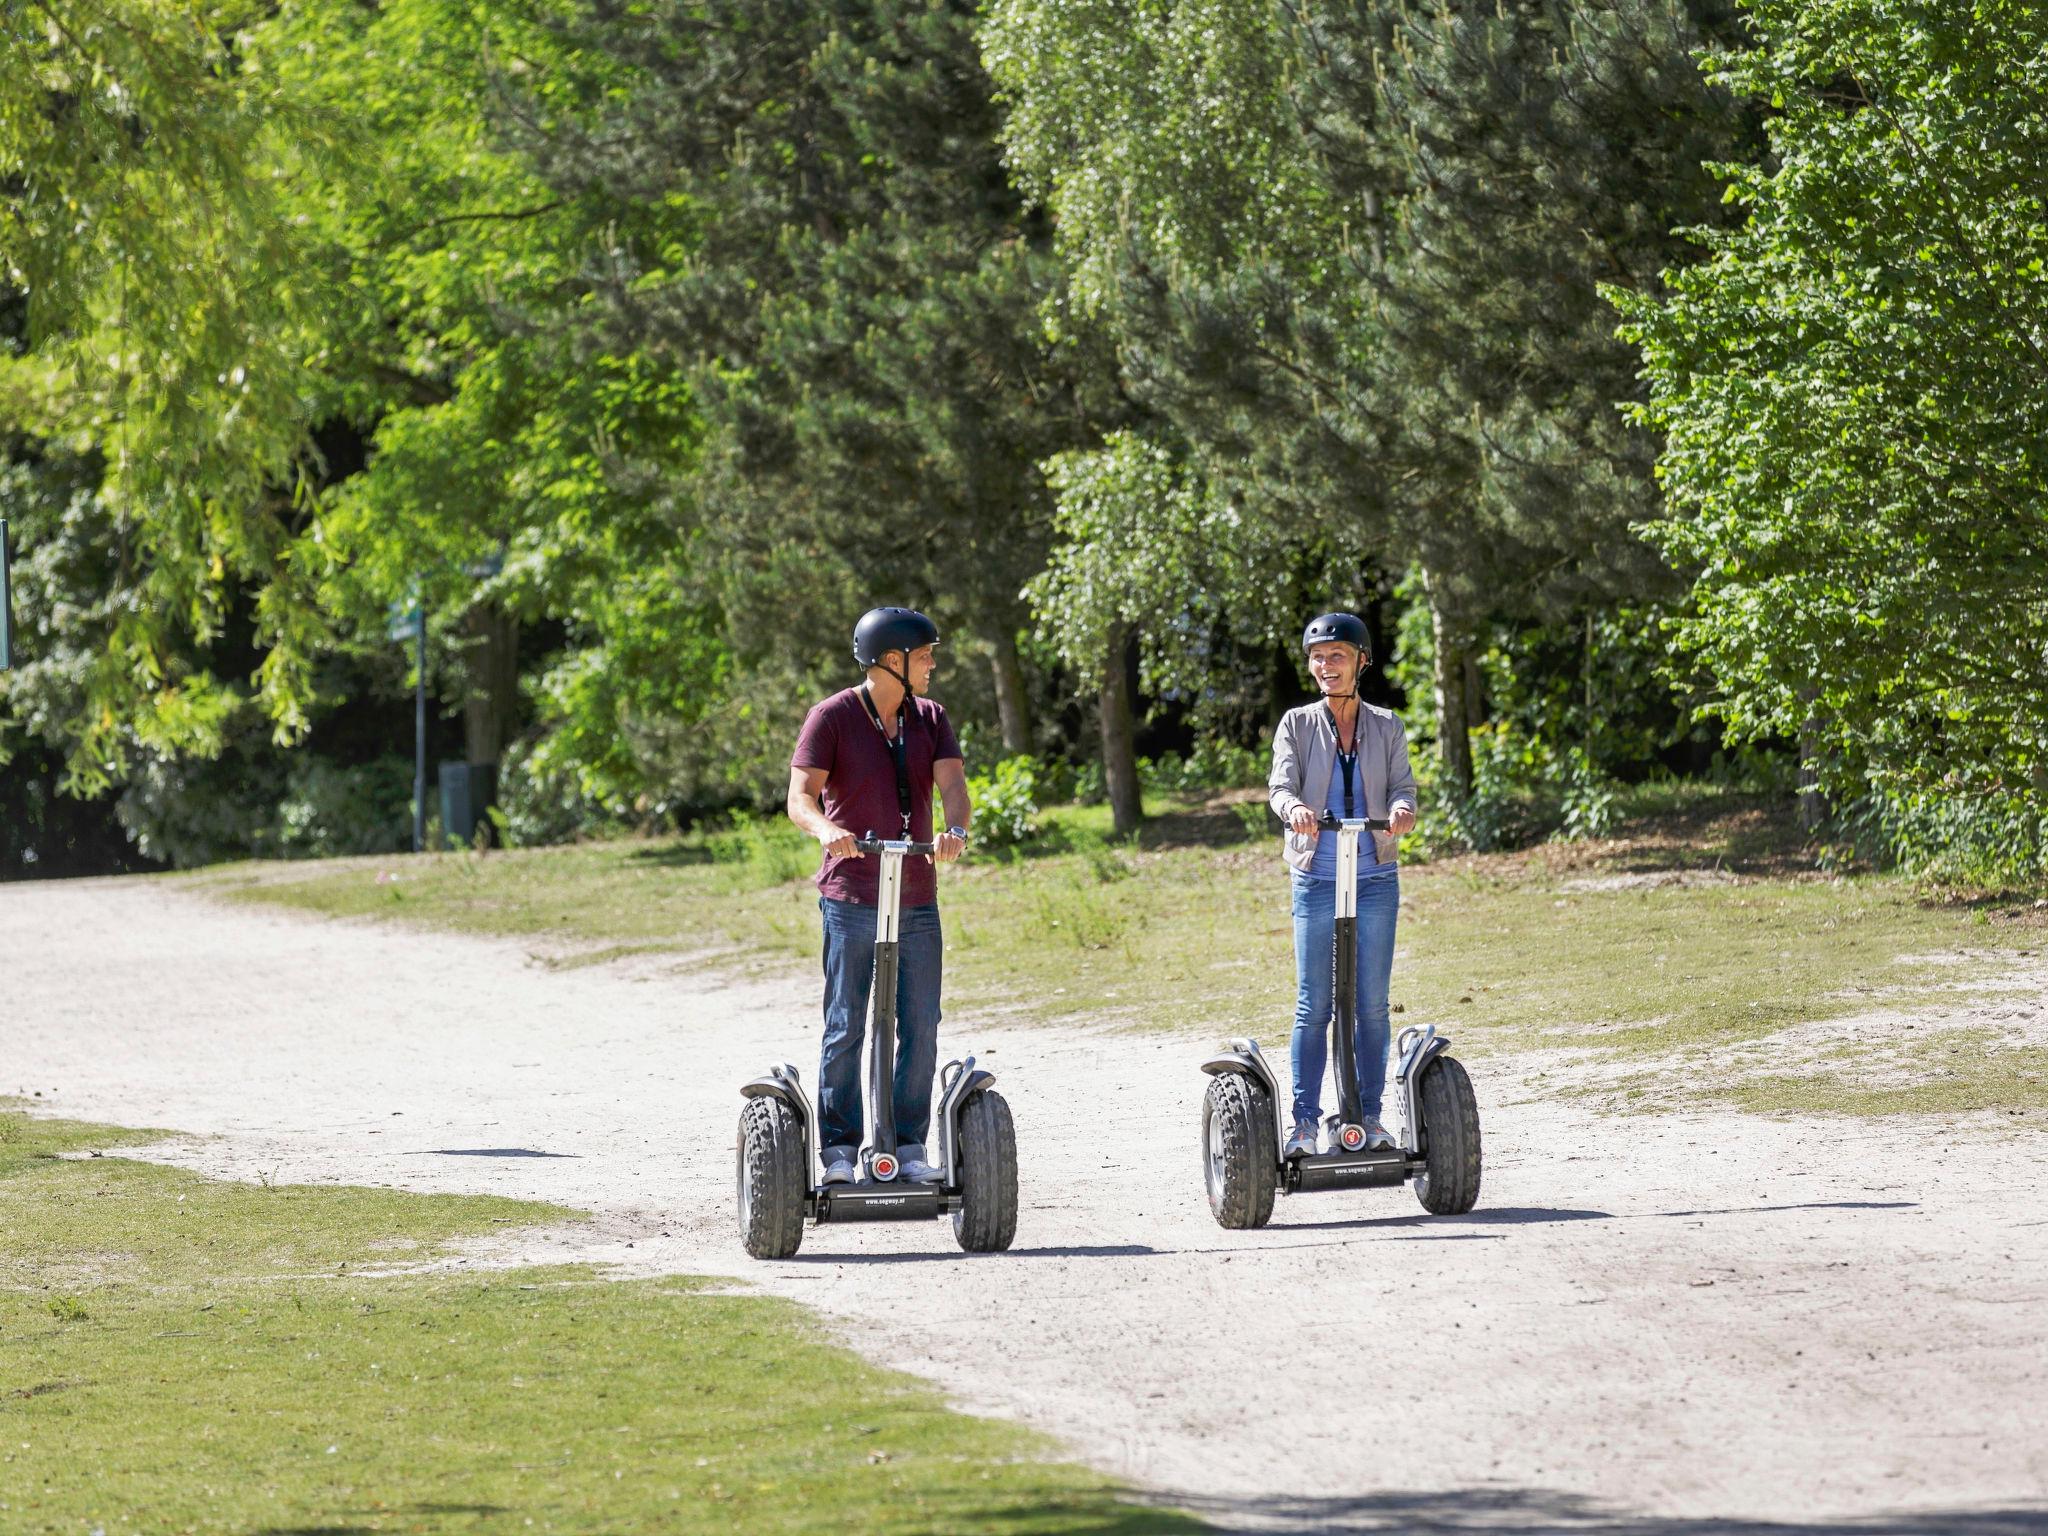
xmin=817 ymin=897 xmax=942 ymax=1151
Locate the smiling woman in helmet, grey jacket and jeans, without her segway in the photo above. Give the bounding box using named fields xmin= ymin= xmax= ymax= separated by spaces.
xmin=1266 ymin=612 xmax=1417 ymax=1157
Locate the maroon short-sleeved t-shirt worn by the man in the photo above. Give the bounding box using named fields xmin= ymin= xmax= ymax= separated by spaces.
xmin=788 ymin=688 xmax=961 ymax=907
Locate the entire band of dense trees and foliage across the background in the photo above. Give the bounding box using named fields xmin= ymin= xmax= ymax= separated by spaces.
xmin=0 ymin=0 xmax=2048 ymax=883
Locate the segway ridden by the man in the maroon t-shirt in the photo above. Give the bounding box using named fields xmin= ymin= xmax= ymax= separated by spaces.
xmin=737 ymin=834 xmax=1018 ymax=1260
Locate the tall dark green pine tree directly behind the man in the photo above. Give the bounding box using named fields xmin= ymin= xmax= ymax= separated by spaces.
xmin=530 ymin=0 xmax=1108 ymax=770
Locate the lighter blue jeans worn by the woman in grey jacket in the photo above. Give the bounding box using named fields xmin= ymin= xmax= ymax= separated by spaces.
xmin=1294 ymin=872 xmax=1401 ymax=1124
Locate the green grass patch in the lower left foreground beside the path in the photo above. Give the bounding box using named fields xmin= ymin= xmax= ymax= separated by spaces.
xmin=0 ymin=1110 xmax=1200 ymax=1536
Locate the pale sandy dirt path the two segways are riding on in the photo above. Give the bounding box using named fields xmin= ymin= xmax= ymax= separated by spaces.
xmin=0 ymin=881 xmax=2048 ymax=1536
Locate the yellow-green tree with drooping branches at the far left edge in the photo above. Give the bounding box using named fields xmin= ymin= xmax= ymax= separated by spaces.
xmin=0 ymin=0 xmax=346 ymax=788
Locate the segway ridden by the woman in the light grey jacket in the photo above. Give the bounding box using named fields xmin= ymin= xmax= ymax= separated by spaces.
xmin=1202 ymin=811 xmax=1479 ymax=1227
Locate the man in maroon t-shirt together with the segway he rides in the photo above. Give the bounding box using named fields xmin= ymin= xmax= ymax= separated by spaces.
xmin=735 ymin=608 xmax=1018 ymax=1260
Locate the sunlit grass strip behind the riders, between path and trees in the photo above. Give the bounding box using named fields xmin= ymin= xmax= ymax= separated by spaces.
xmin=195 ymin=795 xmax=2048 ymax=1112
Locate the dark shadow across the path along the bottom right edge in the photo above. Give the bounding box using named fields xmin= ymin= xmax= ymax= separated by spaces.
xmin=1176 ymin=1487 xmax=2048 ymax=1536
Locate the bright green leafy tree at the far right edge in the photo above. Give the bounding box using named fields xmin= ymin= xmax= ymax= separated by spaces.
xmin=1618 ymin=0 xmax=2048 ymax=877
